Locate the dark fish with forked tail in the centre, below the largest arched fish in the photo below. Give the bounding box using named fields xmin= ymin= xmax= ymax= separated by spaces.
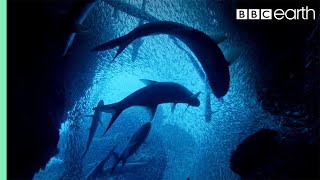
xmin=93 ymin=79 xmax=200 ymax=135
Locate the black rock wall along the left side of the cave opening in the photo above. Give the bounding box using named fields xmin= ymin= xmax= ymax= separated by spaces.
xmin=8 ymin=1 xmax=64 ymax=179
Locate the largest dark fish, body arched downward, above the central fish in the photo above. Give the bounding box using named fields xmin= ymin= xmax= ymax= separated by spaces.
xmin=92 ymin=21 xmax=230 ymax=98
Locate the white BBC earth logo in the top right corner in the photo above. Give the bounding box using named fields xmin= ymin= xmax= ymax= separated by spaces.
xmin=236 ymin=6 xmax=316 ymax=20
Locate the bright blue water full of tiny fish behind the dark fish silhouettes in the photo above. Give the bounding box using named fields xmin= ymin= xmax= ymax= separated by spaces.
xmin=34 ymin=0 xmax=274 ymax=179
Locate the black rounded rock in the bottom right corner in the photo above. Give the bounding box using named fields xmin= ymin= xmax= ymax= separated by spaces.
xmin=230 ymin=129 xmax=320 ymax=179
